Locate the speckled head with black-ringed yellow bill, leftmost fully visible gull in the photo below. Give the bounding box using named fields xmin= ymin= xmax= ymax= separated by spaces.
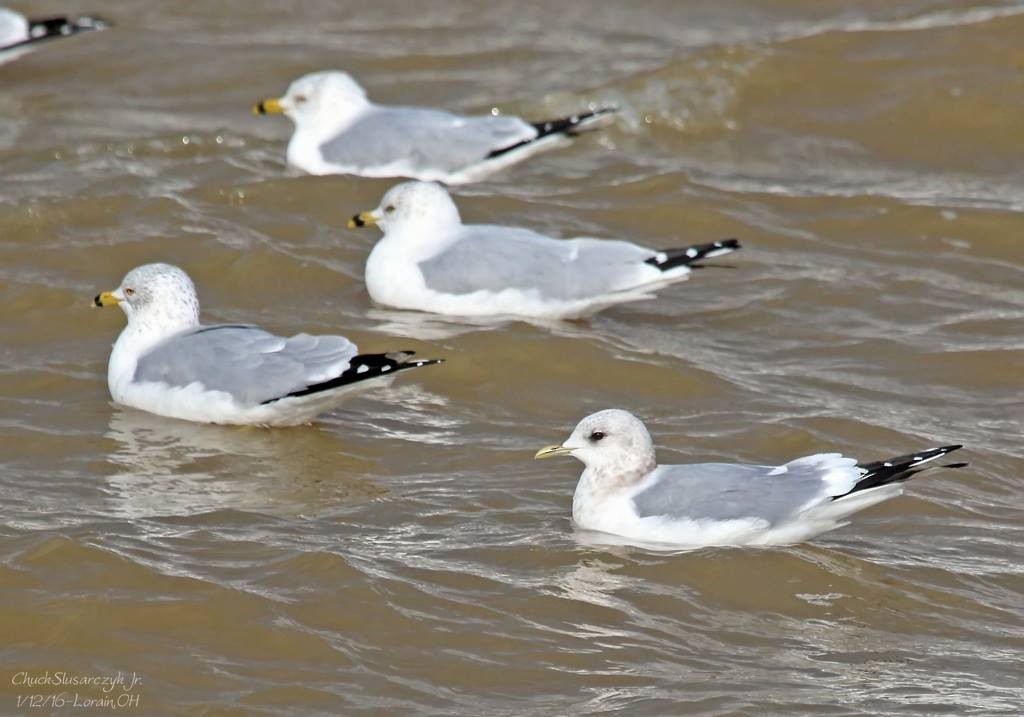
xmin=92 ymin=264 xmax=199 ymax=333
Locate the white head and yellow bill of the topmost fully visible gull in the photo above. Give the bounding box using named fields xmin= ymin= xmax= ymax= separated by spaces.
xmin=253 ymin=71 xmax=370 ymax=125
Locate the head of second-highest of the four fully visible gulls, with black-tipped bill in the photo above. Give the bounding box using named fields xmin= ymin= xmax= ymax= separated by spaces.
xmin=348 ymin=181 xmax=462 ymax=233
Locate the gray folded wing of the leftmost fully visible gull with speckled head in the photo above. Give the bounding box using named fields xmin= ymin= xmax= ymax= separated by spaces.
xmin=134 ymin=326 xmax=356 ymax=405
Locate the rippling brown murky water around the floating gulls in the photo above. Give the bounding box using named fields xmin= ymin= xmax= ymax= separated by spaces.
xmin=0 ymin=0 xmax=1024 ymax=716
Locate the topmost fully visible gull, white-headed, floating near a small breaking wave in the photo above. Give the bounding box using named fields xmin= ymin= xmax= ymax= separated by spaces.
xmin=253 ymin=72 xmax=614 ymax=184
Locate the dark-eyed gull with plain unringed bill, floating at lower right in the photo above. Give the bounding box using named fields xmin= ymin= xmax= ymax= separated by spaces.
xmin=536 ymin=409 xmax=967 ymax=548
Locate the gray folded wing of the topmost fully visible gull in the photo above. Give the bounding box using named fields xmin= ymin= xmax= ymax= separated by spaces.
xmin=321 ymin=108 xmax=537 ymax=172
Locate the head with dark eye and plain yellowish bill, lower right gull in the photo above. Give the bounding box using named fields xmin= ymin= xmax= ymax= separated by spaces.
xmin=535 ymin=409 xmax=657 ymax=483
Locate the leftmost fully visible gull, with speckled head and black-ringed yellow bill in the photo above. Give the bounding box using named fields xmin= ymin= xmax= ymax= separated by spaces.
xmin=93 ymin=263 xmax=440 ymax=426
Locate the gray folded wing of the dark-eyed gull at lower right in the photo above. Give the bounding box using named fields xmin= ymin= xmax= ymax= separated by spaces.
xmin=633 ymin=453 xmax=862 ymax=524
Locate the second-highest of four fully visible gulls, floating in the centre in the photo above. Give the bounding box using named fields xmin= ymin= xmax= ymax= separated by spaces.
xmin=348 ymin=181 xmax=740 ymax=319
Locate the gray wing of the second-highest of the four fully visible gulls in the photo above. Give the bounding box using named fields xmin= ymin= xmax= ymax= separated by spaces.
xmin=420 ymin=225 xmax=658 ymax=300
